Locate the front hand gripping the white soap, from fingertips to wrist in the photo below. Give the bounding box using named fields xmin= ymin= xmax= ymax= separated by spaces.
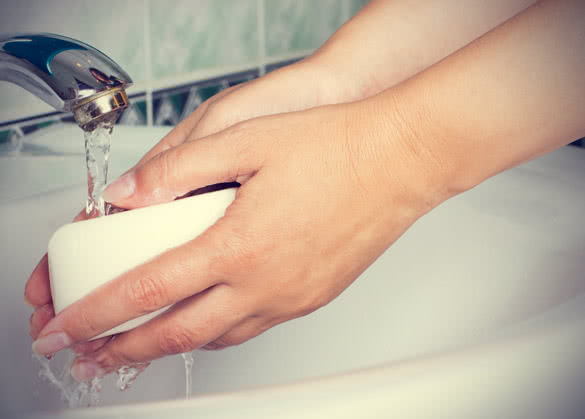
xmin=28 ymin=93 xmax=448 ymax=379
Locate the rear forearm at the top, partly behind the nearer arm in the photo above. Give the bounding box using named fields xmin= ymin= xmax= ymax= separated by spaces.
xmin=308 ymin=0 xmax=535 ymax=103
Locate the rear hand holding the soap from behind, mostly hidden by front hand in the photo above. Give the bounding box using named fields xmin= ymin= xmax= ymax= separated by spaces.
xmin=25 ymin=57 xmax=356 ymax=353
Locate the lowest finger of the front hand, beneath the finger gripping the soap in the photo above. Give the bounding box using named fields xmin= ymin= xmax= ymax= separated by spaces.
xmin=71 ymin=285 xmax=245 ymax=381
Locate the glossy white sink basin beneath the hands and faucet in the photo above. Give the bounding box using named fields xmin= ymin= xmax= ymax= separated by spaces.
xmin=0 ymin=126 xmax=585 ymax=419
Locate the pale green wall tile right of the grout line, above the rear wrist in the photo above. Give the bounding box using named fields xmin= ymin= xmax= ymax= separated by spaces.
xmin=264 ymin=0 xmax=344 ymax=56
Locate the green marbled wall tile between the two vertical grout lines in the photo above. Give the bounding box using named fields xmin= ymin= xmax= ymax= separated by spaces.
xmin=150 ymin=0 xmax=258 ymax=78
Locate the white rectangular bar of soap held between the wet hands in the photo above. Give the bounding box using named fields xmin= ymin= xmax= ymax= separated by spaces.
xmin=48 ymin=188 xmax=236 ymax=338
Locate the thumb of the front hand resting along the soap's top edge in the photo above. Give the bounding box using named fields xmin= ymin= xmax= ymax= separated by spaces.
xmin=103 ymin=121 xmax=263 ymax=208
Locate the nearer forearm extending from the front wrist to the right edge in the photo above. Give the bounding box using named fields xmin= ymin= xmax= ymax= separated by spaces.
xmin=372 ymin=0 xmax=585 ymax=200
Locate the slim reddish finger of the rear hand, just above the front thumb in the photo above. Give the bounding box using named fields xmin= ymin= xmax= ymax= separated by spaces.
xmin=129 ymin=84 xmax=242 ymax=171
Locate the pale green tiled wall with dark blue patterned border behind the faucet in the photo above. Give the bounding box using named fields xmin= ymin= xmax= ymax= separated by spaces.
xmin=0 ymin=0 xmax=367 ymax=136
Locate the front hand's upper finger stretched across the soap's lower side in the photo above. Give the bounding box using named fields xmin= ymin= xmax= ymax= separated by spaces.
xmin=33 ymin=224 xmax=228 ymax=355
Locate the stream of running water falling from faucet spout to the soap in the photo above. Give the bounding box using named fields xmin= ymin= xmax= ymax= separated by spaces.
xmin=84 ymin=121 xmax=114 ymax=218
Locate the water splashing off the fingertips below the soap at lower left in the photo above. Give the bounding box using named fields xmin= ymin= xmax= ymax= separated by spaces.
xmin=33 ymin=351 xmax=102 ymax=408
